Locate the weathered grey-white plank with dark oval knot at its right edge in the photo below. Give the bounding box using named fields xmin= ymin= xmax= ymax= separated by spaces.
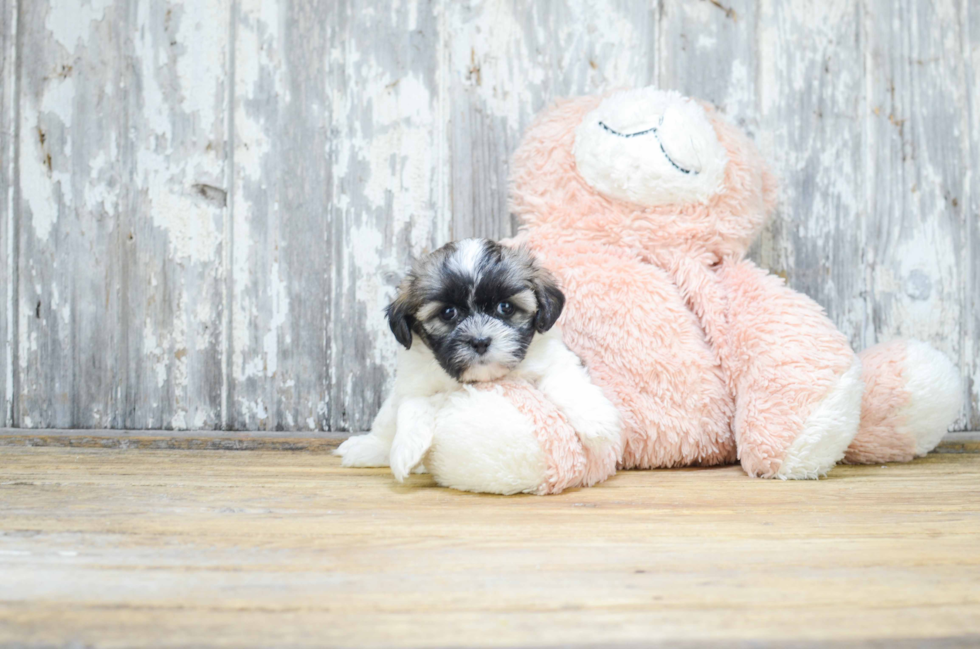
xmin=121 ymin=0 xmax=231 ymax=429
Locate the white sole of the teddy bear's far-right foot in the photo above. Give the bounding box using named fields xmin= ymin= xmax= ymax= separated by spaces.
xmin=901 ymin=340 xmax=963 ymax=456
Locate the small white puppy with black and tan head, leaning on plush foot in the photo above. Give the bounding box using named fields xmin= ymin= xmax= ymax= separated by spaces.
xmin=336 ymin=239 xmax=620 ymax=481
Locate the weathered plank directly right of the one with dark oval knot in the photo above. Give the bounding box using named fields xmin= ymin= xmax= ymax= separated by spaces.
xmin=224 ymin=2 xmax=338 ymax=430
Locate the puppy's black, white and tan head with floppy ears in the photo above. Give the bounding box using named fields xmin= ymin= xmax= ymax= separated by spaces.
xmin=387 ymin=239 xmax=565 ymax=382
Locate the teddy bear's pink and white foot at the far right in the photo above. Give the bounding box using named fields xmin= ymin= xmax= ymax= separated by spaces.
xmin=844 ymin=340 xmax=963 ymax=464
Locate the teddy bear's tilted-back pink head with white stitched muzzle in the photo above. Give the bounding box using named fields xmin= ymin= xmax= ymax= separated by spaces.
xmin=511 ymin=87 xmax=776 ymax=257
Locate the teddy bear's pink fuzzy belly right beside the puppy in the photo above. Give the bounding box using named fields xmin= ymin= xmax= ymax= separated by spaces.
xmin=529 ymin=237 xmax=735 ymax=469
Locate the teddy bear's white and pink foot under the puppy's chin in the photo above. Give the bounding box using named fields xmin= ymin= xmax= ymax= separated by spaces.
xmin=425 ymin=381 xmax=605 ymax=494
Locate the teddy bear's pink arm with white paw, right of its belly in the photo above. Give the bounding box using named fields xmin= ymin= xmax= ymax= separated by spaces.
xmin=719 ymin=261 xmax=863 ymax=479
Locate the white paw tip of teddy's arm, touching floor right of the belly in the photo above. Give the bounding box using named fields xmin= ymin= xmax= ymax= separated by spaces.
xmin=773 ymin=358 xmax=864 ymax=480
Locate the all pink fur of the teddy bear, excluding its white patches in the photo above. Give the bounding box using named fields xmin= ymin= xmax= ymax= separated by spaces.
xmin=498 ymin=88 xmax=948 ymax=492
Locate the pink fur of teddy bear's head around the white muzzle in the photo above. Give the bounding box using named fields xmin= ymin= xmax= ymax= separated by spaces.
xmin=511 ymin=96 xmax=776 ymax=259
